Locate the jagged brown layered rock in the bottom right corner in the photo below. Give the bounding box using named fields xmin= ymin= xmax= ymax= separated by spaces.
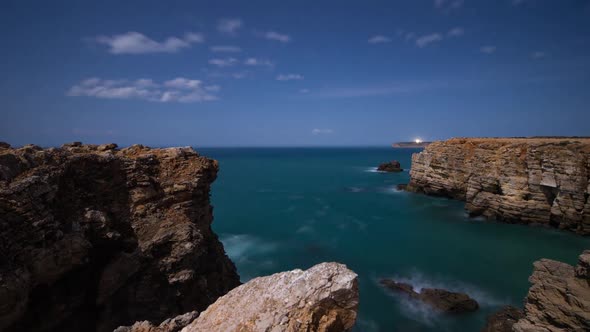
xmin=512 ymin=250 xmax=590 ymax=332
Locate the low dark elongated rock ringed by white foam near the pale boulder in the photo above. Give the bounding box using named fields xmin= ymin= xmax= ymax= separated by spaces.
xmin=380 ymin=279 xmax=479 ymax=313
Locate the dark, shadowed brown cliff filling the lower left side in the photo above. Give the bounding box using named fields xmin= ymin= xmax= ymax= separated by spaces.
xmin=0 ymin=143 xmax=239 ymax=331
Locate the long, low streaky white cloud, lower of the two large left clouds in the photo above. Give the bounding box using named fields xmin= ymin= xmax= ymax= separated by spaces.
xmin=66 ymin=77 xmax=220 ymax=103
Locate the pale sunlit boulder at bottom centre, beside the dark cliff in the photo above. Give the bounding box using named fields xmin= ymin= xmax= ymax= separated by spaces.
xmin=182 ymin=263 xmax=359 ymax=332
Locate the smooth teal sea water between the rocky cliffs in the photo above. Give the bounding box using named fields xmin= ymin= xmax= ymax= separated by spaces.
xmin=197 ymin=148 xmax=590 ymax=332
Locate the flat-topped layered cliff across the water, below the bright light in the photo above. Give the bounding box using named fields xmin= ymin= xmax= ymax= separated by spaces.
xmin=407 ymin=138 xmax=590 ymax=235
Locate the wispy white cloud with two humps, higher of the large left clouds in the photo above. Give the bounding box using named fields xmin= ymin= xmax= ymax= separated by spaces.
xmin=95 ymin=31 xmax=205 ymax=54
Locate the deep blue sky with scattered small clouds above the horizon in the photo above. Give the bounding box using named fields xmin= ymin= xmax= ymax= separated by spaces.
xmin=0 ymin=0 xmax=590 ymax=146
